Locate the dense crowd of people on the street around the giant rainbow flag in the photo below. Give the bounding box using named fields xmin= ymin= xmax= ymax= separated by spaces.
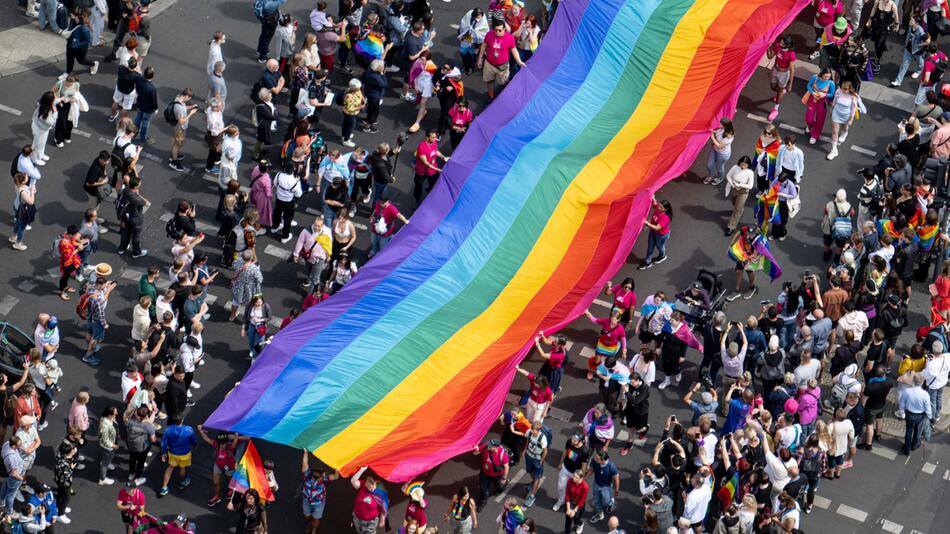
xmin=0 ymin=0 xmax=950 ymax=534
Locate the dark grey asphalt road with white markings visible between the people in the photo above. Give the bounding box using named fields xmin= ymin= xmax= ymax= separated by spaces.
xmin=0 ymin=0 xmax=950 ymax=534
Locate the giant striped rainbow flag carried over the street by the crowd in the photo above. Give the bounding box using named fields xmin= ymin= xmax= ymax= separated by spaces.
xmin=207 ymin=0 xmax=809 ymax=482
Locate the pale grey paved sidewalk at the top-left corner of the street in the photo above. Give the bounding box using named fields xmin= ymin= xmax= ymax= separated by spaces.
xmin=0 ymin=0 xmax=175 ymax=78
